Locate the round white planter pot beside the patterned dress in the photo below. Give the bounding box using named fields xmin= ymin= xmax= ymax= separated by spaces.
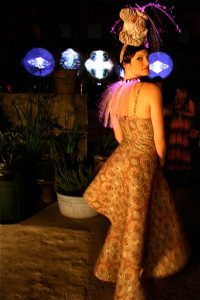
xmin=56 ymin=192 xmax=98 ymax=219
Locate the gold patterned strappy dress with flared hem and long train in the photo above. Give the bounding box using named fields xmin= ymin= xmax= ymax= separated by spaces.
xmin=84 ymin=87 xmax=190 ymax=300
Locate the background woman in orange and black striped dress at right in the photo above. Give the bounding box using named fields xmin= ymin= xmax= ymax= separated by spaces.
xmin=165 ymin=84 xmax=195 ymax=171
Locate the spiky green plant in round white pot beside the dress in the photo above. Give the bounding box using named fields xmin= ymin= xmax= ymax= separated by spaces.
xmin=51 ymin=120 xmax=97 ymax=219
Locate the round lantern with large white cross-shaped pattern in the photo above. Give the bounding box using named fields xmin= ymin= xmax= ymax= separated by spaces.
xmin=85 ymin=50 xmax=114 ymax=79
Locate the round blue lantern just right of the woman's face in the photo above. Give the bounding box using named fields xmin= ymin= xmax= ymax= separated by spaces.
xmin=149 ymin=52 xmax=173 ymax=78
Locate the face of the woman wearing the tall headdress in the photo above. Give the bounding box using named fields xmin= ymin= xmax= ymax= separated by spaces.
xmin=124 ymin=49 xmax=149 ymax=78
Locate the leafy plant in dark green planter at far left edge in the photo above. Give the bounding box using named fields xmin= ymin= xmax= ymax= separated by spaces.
xmin=0 ymin=129 xmax=25 ymax=223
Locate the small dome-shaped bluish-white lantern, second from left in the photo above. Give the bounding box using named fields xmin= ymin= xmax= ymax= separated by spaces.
xmin=60 ymin=48 xmax=81 ymax=70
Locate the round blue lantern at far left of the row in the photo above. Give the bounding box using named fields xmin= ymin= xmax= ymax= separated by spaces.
xmin=23 ymin=48 xmax=55 ymax=77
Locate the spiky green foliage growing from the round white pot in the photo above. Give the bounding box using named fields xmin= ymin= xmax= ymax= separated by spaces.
xmin=51 ymin=117 xmax=94 ymax=196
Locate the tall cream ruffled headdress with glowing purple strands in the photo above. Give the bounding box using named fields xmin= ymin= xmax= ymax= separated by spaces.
xmin=111 ymin=2 xmax=180 ymax=63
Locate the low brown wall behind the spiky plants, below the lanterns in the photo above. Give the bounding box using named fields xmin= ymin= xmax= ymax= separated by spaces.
xmin=1 ymin=93 xmax=88 ymax=159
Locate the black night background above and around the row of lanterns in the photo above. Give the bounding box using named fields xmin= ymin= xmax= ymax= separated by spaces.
xmin=0 ymin=0 xmax=200 ymax=105
